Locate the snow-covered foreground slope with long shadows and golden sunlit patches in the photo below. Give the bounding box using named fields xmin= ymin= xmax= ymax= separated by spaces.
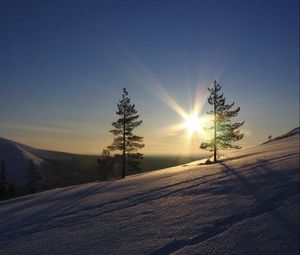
xmin=0 ymin=130 xmax=299 ymax=255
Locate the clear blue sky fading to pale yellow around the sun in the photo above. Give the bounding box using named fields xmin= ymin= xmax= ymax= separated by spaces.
xmin=0 ymin=0 xmax=299 ymax=153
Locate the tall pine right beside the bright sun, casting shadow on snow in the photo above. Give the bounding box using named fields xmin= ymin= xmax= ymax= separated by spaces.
xmin=200 ymin=81 xmax=244 ymax=162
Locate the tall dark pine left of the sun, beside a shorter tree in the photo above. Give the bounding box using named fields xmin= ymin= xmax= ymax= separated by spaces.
xmin=108 ymin=88 xmax=145 ymax=178
